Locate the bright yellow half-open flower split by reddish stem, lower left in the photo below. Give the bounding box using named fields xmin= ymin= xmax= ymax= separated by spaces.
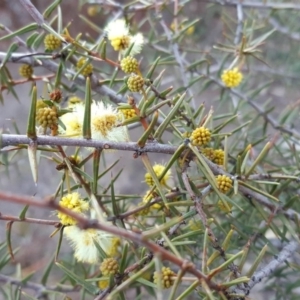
xmin=57 ymin=193 xmax=90 ymax=225
